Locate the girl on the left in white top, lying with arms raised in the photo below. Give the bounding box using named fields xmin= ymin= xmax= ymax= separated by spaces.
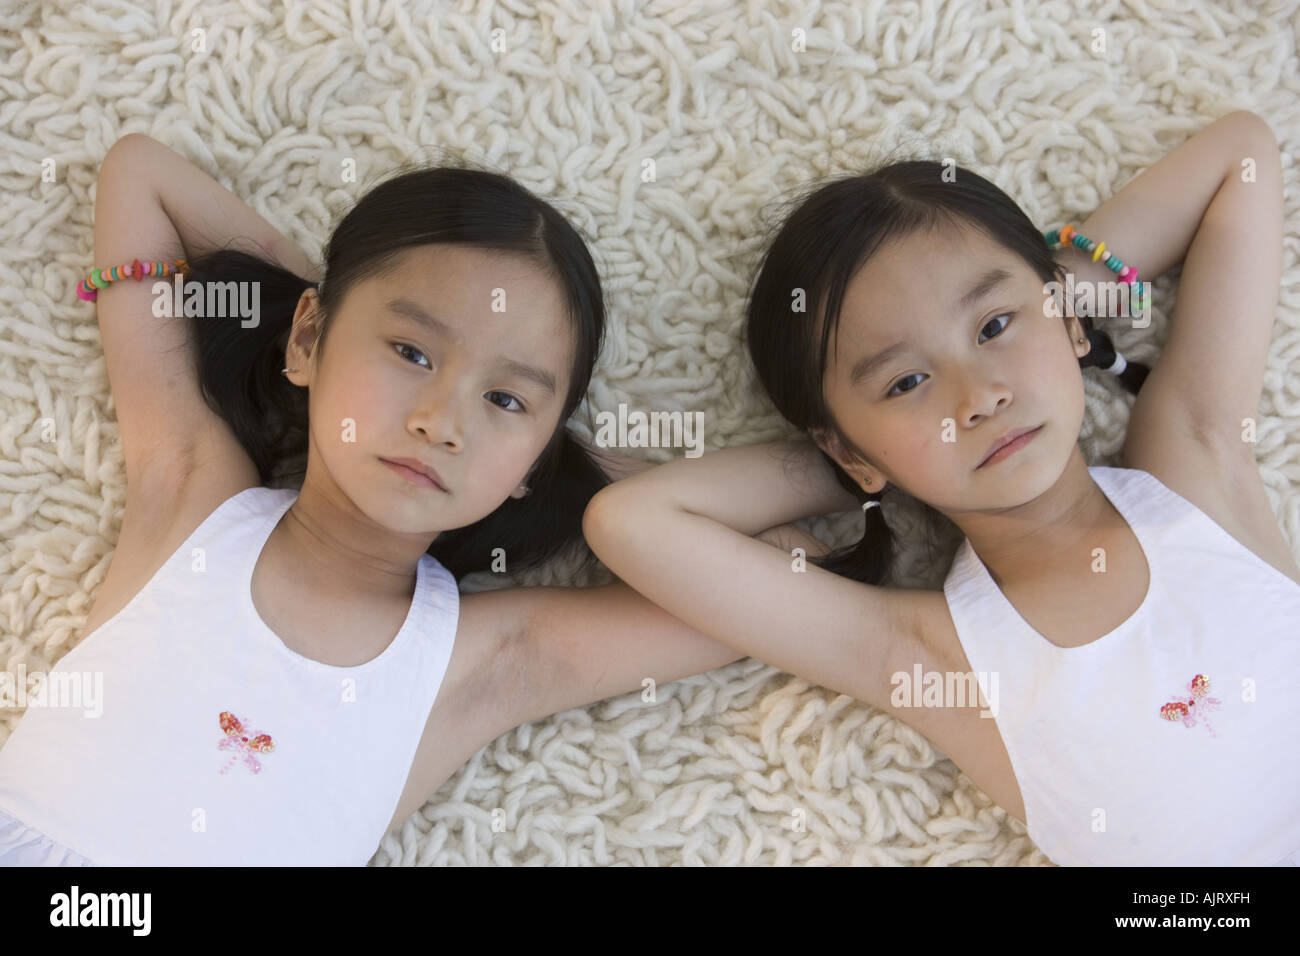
xmin=0 ymin=128 xmax=815 ymax=865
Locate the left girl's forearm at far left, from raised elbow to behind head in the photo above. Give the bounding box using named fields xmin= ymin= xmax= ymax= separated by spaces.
xmin=112 ymin=133 xmax=320 ymax=282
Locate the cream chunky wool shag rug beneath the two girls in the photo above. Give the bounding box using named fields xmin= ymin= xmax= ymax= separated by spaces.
xmin=0 ymin=0 xmax=1300 ymax=865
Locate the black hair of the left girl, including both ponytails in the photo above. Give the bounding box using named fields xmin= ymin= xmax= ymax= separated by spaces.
xmin=185 ymin=166 xmax=608 ymax=578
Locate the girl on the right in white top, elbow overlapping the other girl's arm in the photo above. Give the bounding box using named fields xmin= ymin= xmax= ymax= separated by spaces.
xmin=584 ymin=112 xmax=1300 ymax=865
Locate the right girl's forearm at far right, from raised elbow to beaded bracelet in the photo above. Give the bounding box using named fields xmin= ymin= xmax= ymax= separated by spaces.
xmin=1056 ymin=112 xmax=1258 ymax=290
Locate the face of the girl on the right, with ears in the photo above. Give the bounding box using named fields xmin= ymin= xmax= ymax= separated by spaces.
xmin=814 ymin=226 xmax=1091 ymax=518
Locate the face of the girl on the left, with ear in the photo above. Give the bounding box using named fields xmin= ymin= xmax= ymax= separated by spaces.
xmin=287 ymin=245 xmax=573 ymax=533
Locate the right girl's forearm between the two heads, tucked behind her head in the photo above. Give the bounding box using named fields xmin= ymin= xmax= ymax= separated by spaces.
xmin=593 ymin=438 xmax=858 ymax=537
